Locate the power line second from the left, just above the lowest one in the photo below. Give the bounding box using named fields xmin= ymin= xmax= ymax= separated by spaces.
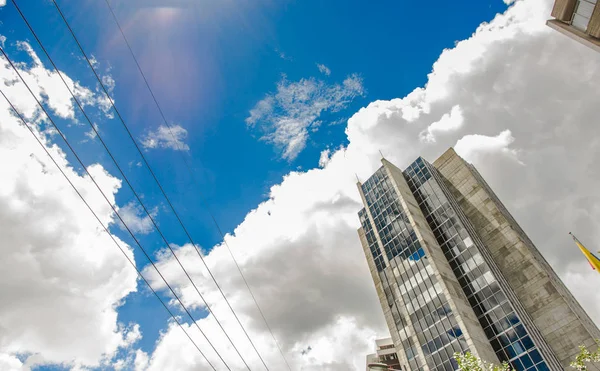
xmin=0 ymin=46 xmax=231 ymax=370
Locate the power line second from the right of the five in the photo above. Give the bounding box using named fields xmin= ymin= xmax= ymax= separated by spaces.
xmin=49 ymin=0 xmax=269 ymax=370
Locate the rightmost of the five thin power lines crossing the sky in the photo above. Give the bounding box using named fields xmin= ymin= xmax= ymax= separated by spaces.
xmin=105 ymin=0 xmax=291 ymax=371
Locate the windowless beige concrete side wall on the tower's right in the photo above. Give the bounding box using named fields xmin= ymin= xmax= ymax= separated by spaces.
xmin=434 ymin=149 xmax=600 ymax=370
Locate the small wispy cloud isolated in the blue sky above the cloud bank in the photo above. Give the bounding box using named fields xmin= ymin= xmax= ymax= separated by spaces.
xmin=246 ymin=75 xmax=364 ymax=160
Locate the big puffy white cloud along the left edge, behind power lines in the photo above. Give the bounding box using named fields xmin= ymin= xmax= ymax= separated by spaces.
xmin=0 ymin=35 xmax=137 ymax=370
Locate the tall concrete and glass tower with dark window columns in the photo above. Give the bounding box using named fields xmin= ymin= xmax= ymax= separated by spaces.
xmin=358 ymin=149 xmax=600 ymax=371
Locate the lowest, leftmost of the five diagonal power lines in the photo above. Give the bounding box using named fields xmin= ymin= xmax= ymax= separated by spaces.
xmin=0 ymin=89 xmax=215 ymax=370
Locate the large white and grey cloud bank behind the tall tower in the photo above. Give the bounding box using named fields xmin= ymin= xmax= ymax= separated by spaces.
xmin=138 ymin=0 xmax=600 ymax=370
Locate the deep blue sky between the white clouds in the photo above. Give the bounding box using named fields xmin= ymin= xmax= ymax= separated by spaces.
xmin=0 ymin=0 xmax=560 ymax=370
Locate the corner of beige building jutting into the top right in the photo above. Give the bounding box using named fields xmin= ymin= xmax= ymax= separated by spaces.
xmin=547 ymin=0 xmax=600 ymax=51
